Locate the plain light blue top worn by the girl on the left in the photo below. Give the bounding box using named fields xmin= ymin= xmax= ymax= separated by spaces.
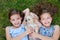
xmin=9 ymin=25 xmax=28 ymax=40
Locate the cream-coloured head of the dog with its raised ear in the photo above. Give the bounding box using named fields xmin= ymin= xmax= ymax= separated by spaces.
xmin=23 ymin=8 xmax=38 ymax=23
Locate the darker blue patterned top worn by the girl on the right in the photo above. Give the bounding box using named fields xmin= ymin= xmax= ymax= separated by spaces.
xmin=39 ymin=25 xmax=55 ymax=37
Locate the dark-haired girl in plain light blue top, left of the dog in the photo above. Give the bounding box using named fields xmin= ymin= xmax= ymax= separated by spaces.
xmin=6 ymin=9 xmax=32 ymax=40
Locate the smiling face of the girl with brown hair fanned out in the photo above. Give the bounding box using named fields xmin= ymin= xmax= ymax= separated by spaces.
xmin=40 ymin=13 xmax=52 ymax=27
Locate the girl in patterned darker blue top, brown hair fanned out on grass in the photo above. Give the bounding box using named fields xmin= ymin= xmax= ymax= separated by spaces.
xmin=31 ymin=9 xmax=59 ymax=40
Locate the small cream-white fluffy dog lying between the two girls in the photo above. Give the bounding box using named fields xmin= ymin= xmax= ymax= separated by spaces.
xmin=23 ymin=8 xmax=40 ymax=40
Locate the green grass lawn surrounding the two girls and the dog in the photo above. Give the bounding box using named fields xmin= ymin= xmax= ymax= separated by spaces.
xmin=0 ymin=0 xmax=60 ymax=40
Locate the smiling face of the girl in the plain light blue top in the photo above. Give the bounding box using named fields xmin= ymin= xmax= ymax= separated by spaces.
xmin=10 ymin=14 xmax=22 ymax=28
